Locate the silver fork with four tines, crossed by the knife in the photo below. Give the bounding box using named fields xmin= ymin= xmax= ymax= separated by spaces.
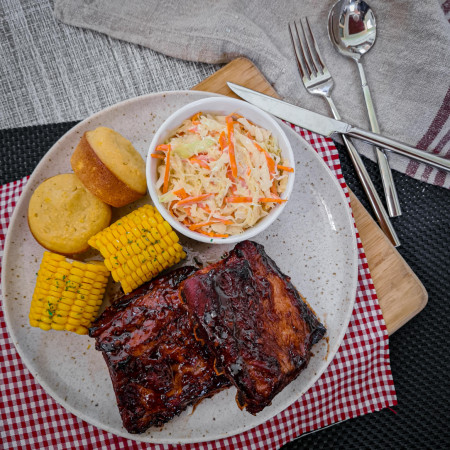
xmin=289 ymin=18 xmax=400 ymax=247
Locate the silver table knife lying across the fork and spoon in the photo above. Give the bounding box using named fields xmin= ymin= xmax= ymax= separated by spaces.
xmin=227 ymin=82 xmax=450 ymax=172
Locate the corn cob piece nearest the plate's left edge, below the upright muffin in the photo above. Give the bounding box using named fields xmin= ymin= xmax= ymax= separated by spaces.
xmin=29 ymin=252 xmax=109 ymax=334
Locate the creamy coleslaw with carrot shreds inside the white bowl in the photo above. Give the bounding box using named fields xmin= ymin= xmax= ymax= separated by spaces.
xmin=154 ymin=113 xmax=293 ymax=237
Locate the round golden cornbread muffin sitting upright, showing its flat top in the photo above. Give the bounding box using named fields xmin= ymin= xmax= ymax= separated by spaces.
xmin=28 ymin=173 xmax=111 ymax=255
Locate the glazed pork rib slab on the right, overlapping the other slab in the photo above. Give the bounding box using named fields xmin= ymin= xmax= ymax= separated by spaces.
xmin=180 ymin=241 xmax=326 ymax=414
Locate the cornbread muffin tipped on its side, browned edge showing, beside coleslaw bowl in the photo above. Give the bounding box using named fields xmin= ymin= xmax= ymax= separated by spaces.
xmin=70 ymin=127 xmax=147 ymax=208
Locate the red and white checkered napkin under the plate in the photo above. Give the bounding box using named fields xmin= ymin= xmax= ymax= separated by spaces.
xmin=0 ymin=126 xmax=397 ymax=450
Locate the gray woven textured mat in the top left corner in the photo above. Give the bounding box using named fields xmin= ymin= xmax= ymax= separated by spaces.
xmin=0 ymin=0 xmax=220 ymax=130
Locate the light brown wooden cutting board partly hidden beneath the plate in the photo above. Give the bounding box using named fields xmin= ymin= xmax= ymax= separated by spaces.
xmin=193 ymin=58 xmax=428 ymax=334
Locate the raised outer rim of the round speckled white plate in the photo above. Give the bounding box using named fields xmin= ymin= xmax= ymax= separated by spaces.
xmin=1 ymin=90 xmax=358 ymax=445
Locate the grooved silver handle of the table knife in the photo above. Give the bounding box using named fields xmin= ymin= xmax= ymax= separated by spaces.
xmin=345 ymin=126 xmax=450 ymax=172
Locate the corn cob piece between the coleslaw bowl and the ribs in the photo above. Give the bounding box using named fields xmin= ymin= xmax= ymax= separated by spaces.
xmin=88 ymin=205 xmax=186 ymax=294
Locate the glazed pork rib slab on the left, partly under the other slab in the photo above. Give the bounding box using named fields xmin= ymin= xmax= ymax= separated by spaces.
xmin=89 ymin=267 xmax=230 ymax=433
